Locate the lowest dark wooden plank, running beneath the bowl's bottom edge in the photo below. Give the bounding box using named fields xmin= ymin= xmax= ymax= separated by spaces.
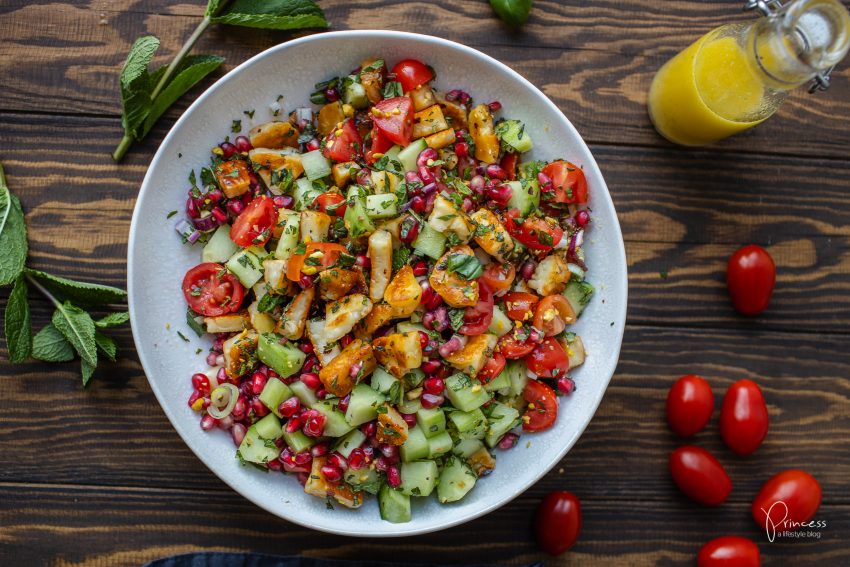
xmin=0 ymin=480 xmax=850 ymax=567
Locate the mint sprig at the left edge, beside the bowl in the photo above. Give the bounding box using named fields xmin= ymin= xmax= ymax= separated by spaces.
xmin=0 ymin=165 xmax=129 ymax=385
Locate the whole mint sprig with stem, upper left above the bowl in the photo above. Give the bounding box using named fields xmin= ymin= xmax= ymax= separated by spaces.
xmin=112 ymin=0 xmax=328 ymax=162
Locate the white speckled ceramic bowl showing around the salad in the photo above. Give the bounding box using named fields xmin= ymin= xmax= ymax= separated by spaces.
xmin=127 ymin=31 xmax=627 ymax=537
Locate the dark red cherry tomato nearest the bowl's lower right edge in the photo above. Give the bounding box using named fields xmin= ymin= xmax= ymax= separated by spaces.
xmin=534 ymin=491 xmax=581 ymax=555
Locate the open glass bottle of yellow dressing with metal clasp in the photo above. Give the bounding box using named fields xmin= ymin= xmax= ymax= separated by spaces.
xmin=648 ymin=0 xmax=850 ymax=146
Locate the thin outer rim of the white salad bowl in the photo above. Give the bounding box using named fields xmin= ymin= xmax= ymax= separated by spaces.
xmin=127 ymin=29 xmax=628 ymax=538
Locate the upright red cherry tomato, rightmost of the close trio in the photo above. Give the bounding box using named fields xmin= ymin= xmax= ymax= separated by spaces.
xmin=720 ymin=380 xmax=770 ymax=456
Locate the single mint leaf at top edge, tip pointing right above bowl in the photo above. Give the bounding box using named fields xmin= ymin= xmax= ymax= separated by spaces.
xmin=212 ymin=0 xmax=328 ymax=30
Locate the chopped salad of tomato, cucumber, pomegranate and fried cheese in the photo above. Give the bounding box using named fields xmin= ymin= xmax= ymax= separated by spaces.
xmin=177 ymin=56 xmax=592 ymax=523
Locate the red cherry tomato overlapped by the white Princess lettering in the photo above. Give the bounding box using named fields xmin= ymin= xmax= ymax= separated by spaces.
xmin=752 ymin=469 xmax=823 ymax=535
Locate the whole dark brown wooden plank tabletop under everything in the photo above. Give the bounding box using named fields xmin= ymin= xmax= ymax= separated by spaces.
xmin=0 ymin=0 xmax=850 ymax=566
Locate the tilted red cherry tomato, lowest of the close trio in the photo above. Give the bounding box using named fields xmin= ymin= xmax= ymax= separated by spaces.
xmin=669 ymin=445 xmax=732 ymax=506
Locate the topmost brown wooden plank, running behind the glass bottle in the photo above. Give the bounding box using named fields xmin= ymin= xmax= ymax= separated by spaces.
xmin=0 ymin=0 xmax=850 ymax=158
